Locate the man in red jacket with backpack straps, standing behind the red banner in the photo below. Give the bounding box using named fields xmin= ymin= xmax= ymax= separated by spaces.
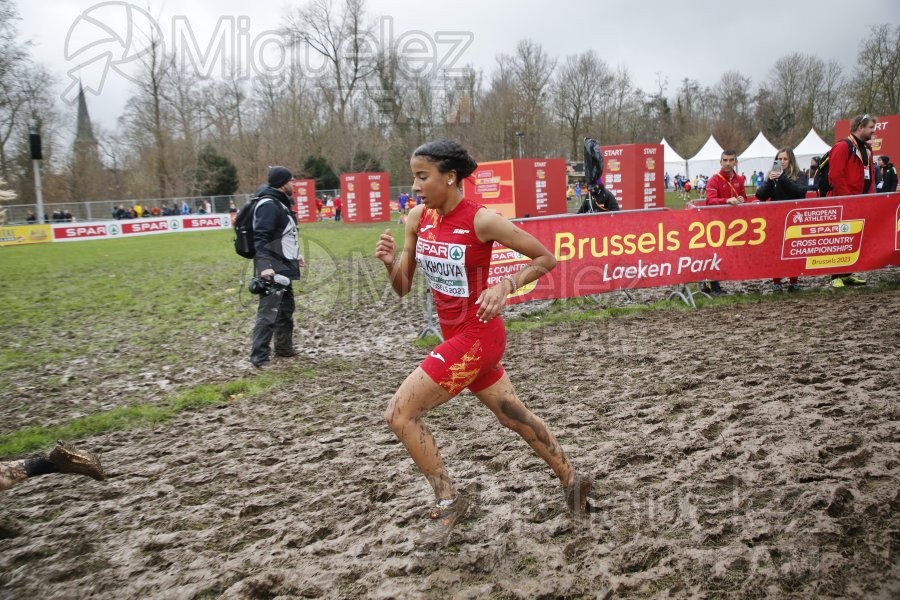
xmin=828 ymin=114 xmax=878 ymax=288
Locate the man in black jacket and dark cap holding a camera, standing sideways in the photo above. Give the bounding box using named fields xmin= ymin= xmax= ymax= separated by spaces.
xmin=250 ymin=167 xmax=306 ymax=369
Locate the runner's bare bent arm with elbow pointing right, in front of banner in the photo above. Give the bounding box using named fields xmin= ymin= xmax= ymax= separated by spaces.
xmin=475 ymin=210 xmax=556 ymax=321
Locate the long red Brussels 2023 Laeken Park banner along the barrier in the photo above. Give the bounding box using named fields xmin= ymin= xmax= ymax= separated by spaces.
xmin=488 ymin=193 xmax=900 ymax=303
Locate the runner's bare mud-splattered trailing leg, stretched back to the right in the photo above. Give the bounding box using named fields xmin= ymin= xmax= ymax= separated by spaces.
xmin=475 ymin=374 xmax=575 ymax=487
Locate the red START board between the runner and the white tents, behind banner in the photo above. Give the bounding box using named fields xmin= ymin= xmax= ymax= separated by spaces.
xmin=603 ymin=144 xmax=665 ymax=210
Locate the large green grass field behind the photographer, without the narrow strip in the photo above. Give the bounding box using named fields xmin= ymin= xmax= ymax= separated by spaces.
xmin=0 ymin=223 xmax=399 ymax=374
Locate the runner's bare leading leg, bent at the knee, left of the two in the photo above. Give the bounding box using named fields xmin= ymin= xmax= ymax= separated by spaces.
xmin=385 ymin=367 xmax=456 ymax=500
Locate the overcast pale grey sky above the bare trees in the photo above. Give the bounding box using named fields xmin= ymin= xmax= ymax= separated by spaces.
xmin=17 ymin=0 xmax=900 ymax=135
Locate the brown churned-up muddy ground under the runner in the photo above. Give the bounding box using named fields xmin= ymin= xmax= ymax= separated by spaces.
xmin=0 ymin=269 xmax=900 ymax=599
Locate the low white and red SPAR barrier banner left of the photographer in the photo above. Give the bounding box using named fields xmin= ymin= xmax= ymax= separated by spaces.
xmin=52 ymin=214 xmax=231 ymax=242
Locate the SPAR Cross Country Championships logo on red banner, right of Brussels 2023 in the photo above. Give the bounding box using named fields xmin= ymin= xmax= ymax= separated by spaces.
xmin=781 ymin=206 xmax=865 ymax=269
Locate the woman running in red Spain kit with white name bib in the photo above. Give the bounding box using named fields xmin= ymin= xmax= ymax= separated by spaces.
xmin=375 ymin=140 xmax=592 ymax=541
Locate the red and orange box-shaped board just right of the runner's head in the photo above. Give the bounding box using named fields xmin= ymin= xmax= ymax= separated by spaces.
xmin=463 ymin=158 xmax=566 ymax=218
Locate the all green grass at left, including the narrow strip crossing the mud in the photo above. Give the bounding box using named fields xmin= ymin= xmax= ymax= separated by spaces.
xmin=0 ymin=223 xmax=399 ymax=456
